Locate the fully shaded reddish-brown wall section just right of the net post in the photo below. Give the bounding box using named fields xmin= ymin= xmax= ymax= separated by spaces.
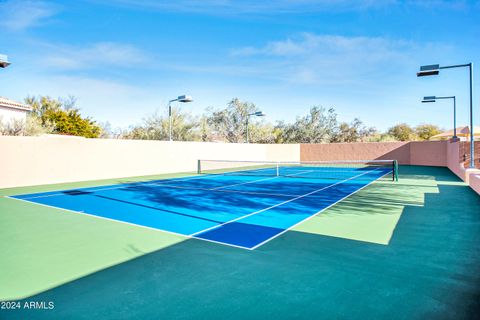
xmin=409 ymin=141 xmax=449 ymax=167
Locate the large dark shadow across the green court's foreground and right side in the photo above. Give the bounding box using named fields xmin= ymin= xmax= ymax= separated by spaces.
xmin=1 ymin=168 xmax=480 ymax=319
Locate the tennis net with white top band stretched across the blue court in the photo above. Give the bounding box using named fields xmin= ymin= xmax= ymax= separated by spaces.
xmin=198 ymin=160 xmax=398 ymax=181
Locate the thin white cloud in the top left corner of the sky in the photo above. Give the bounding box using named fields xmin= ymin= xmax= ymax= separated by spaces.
xmin=0 ymin=0 xmax=59 ymax=31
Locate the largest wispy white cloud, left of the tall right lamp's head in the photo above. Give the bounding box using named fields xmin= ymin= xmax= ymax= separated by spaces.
xmin=227 ymin=33 xmax=449 ymax=84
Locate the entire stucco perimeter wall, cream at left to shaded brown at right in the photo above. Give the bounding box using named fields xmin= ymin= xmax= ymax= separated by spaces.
xmin=0 ymin=136 xmax=480 ymax=192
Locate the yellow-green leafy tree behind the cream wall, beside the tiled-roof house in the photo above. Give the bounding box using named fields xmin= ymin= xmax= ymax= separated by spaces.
xmin=25 ymin=96 xmax=101 ymax=138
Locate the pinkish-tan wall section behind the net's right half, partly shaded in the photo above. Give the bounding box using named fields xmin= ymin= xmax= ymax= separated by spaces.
xmin=300 ymin=142 xmax=410 ymax=164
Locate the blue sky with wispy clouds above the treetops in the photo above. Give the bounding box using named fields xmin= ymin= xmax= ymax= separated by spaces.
xmin=0 ymin=0 xmax=480 ymax=130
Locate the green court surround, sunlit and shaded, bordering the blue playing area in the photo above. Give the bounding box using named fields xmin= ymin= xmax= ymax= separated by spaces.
xmin=0 ymin=166 xmax=480 ymax=319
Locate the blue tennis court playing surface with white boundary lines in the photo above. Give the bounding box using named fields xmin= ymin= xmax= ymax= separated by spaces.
xmin=12 ymin=168 xmax=392 ymax=249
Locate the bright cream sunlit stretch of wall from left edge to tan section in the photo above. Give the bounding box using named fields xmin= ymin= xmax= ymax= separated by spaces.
xmin=0 ymin=136 xmax=300 ymax=188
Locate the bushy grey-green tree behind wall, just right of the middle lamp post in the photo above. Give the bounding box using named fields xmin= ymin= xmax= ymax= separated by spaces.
xmin=276 ymin=106 xmax=337 ymax=143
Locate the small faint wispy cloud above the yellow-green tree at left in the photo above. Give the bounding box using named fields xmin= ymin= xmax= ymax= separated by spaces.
xmin=44 ymin=42 xmax=149 ymax=70
